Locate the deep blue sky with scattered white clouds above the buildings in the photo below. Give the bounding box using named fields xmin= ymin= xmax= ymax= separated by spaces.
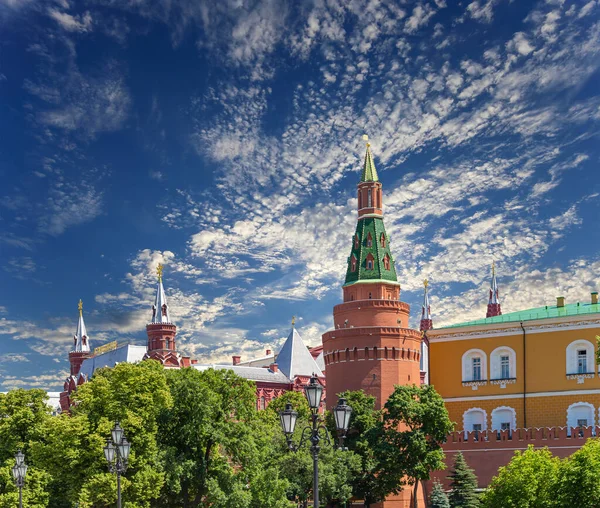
xmin=0 ymin=0 xmax=600 ymax=390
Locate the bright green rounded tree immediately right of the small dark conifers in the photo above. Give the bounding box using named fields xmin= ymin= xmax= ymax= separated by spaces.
xmin=481 ymin=445 xmax=556 ymax=508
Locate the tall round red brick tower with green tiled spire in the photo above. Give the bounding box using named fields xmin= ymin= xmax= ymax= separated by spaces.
xmin=323 ymin=139 xmax=421 ymax=408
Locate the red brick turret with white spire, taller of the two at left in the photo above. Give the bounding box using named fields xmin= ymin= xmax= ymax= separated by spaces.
xmin=145 ymin=264 xmax=187 ymax=368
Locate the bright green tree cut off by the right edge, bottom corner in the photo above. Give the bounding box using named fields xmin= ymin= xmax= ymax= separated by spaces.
xmin=554 ymin=439 xmax=600 ymax=508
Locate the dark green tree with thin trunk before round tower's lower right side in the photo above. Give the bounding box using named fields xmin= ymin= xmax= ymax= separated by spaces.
xmin=373 ymin=385 xmax=453 ymax=508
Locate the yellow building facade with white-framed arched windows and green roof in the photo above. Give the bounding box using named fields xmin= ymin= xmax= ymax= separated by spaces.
xmin=425 ymin=292 xmax=600 ymax=431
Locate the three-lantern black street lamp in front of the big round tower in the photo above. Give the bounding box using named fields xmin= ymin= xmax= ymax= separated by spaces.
xmin=279 ymin=376 xmax=352 ymax=508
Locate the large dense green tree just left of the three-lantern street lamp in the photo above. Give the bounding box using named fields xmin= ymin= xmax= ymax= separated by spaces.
xmin=157 ymin=369 xmax=288 ymax=508
